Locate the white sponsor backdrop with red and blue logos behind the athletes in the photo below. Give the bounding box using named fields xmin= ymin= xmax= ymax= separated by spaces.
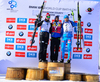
xmin=0 ymin=0 xmax=100 ymax=74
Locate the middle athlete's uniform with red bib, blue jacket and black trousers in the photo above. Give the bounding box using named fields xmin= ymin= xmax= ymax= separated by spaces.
xmin=50 ymin=16 xmax=62 ymax=61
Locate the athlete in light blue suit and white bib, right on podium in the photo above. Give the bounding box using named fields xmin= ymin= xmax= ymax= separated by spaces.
xmin=60 ymin=15 xmax=77 ymax=63
